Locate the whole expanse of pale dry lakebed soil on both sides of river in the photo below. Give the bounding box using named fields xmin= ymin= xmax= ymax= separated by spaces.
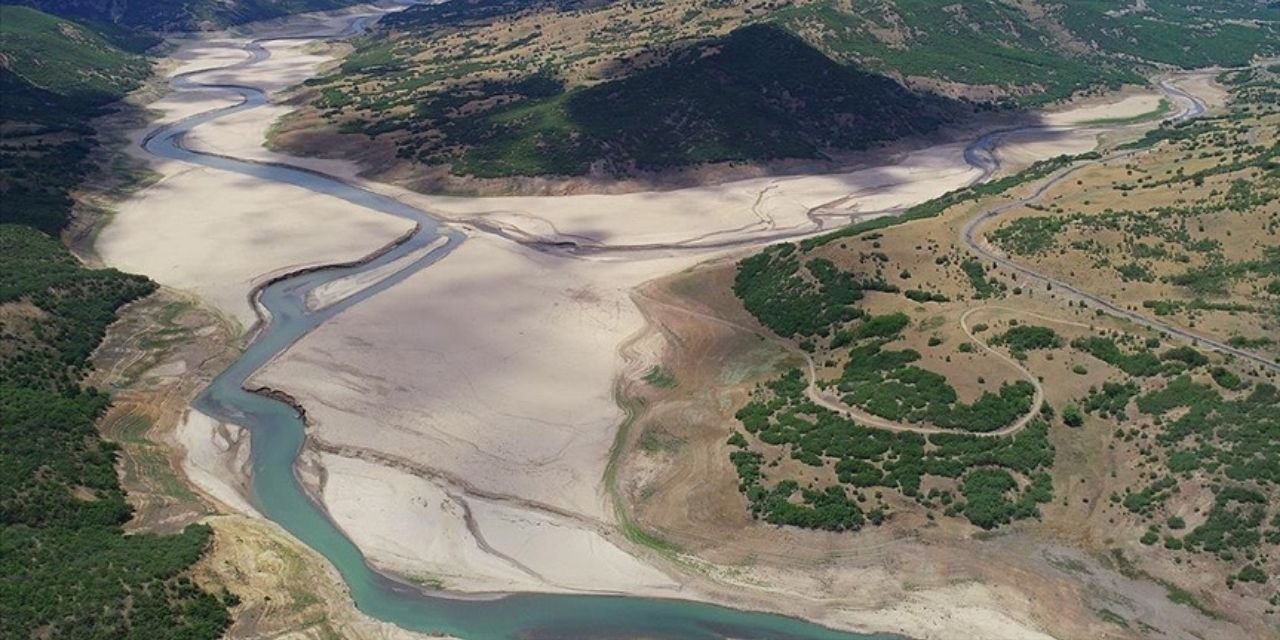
xmin=99 ymin=3 xmax=1218 ymax=637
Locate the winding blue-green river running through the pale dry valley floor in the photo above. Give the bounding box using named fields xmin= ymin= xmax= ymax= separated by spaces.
xmin=142 ymin=11 xmax=888 ymax=640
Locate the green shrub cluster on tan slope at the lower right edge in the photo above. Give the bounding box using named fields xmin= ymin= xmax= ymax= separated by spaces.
xmin=1085 ymin=332 xmax=1280 ymax=585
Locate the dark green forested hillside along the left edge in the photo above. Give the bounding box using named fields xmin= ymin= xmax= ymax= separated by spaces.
xmin=0 ymin=6 xmax=232 ymax=640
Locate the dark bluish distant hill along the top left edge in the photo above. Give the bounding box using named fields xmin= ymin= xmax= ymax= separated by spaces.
xmin=6 ymin=0 xmax=357 ymax=31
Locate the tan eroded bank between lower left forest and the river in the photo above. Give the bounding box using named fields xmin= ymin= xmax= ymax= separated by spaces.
xmin=88 ymin=289 xmax=432 ymax=640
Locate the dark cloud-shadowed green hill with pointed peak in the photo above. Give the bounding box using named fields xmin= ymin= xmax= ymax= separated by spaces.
xmin=442 ymin=24 xmax=964 ymax=177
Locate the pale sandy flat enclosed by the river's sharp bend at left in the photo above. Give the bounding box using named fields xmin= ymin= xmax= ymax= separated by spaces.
xmin=96 ymin=44 xmax=412 ymax=329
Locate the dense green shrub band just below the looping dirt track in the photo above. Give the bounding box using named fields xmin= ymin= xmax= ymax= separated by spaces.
xmin=730 ymin=360 xmax=1053 ymax=530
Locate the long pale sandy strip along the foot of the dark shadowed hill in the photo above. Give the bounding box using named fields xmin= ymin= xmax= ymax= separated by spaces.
xmin=188 ymin=99 xmax=983 ymax=246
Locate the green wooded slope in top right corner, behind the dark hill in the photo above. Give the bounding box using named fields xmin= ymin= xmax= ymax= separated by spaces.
xmin=767 ymin=0 xmax=1280 ymax=106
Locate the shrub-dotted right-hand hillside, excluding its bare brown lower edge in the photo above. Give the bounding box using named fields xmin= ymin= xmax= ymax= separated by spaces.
xmin=727 ymin=64 xmax=1280 ymax=624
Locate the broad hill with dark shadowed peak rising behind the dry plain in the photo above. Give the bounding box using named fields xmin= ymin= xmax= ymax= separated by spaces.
xmin=288 ymin=0 xmax=1280 ymax=183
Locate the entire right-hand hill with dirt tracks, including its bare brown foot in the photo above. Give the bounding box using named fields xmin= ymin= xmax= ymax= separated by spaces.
xmin=620 ymin=65 xmax=1280 ymax=639
